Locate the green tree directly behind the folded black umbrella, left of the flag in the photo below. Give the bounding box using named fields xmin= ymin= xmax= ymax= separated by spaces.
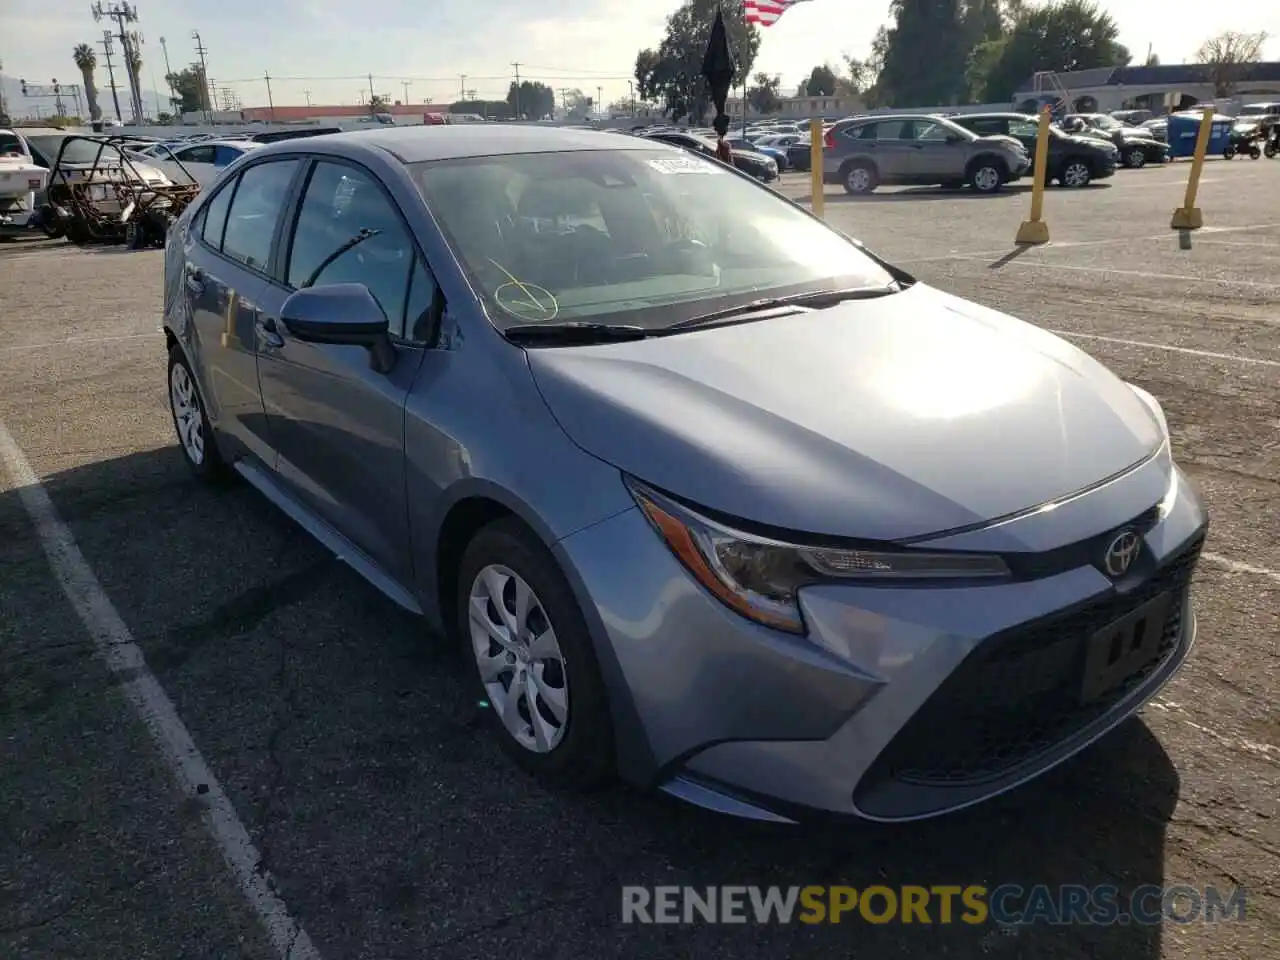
xmin=635 ymin=0 xmax=760 ymax=123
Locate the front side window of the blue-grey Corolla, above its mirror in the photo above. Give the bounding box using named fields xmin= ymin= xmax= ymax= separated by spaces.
xmin=288 ymin=161 xmax=414 ymax=337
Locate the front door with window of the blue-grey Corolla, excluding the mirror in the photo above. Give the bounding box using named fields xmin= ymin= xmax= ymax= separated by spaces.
xmin=257 ymin=159 xmax=434 ymax=582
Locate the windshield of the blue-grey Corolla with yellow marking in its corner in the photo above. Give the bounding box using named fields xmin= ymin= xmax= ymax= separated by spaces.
xmin=410 ymin=148 xmax=892 ymax=329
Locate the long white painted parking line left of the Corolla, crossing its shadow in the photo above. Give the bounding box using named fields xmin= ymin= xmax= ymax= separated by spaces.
xmin=0 ymin=422 xmax=320 ymax=960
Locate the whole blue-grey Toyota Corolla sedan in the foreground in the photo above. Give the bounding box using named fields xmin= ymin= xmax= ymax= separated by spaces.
xmin=164 ymin=124 xmax=1207 ymax=820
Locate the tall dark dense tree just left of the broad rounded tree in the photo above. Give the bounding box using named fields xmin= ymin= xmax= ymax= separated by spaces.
xmin=878 ymin=0 xmax=972 ymax=108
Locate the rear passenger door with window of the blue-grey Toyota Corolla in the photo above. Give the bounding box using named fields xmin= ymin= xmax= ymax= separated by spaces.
xmin=183 ymin=159 xmax=302 ymax=467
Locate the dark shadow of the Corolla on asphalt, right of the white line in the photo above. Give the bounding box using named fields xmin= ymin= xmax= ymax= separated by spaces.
xmin=0 ymin=447 xmax=1179 ymax=960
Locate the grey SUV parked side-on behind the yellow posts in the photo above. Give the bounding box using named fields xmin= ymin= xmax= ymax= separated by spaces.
xmin=822 ymin=114 xmax=1032 ymax=193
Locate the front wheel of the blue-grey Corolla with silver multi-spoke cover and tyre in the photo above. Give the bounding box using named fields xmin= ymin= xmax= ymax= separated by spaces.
xmin=457 ymin=520 xmax=616 ymax=790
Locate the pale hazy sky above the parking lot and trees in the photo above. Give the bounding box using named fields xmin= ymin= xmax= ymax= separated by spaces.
xmin=0 ymin=0 xmax=1280 ymax=106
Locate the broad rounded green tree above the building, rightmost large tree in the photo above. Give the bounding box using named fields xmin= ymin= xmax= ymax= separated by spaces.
xmin=968 ymin=0 xmax=1130 ymax=102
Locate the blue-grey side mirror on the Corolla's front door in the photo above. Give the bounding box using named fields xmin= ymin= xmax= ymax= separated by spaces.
xmin=280 ymin=283 xmax=396 ymax=372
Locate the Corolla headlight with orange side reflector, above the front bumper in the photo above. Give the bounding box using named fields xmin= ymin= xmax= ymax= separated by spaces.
xmin=627 ymin=477 xmax=1009 ymax=634
